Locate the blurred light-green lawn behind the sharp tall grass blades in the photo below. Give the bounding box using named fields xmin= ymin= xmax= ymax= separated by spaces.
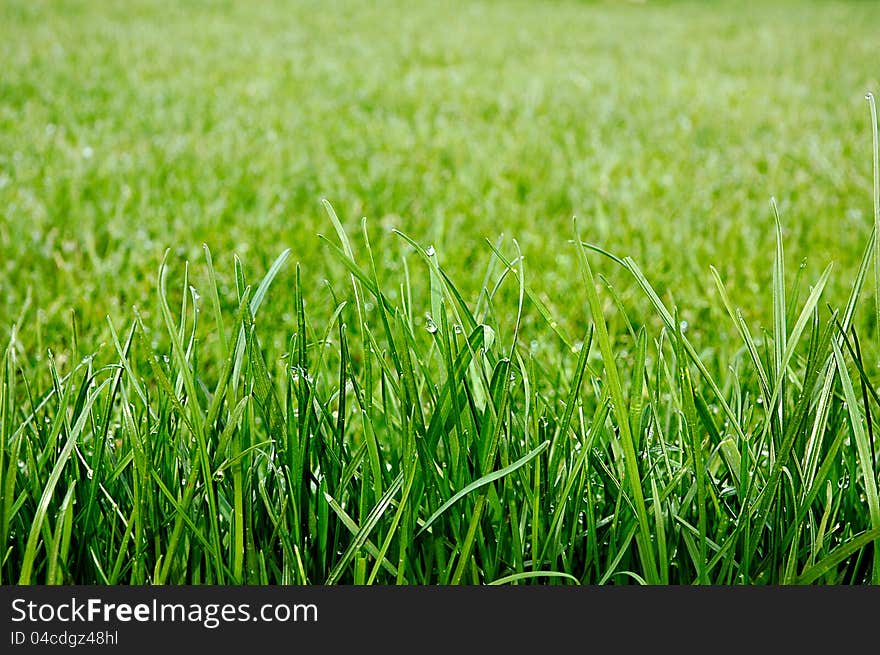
xmin=0 ymin=0 xmax=880 ymax=358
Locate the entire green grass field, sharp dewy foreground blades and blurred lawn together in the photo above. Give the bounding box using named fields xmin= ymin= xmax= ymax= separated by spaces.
xmin=0 ymin=0 xmax=880 ymax=584
